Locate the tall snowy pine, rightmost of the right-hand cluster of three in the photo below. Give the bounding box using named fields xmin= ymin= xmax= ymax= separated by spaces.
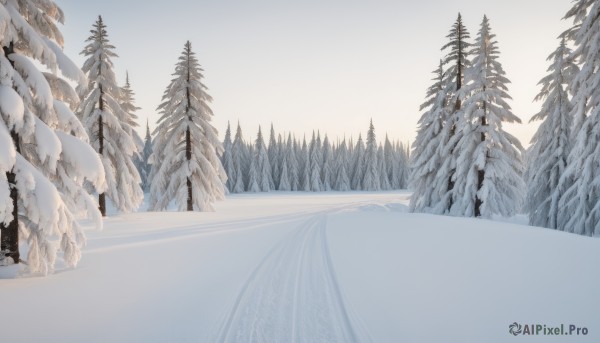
xmin=451 ymin=16 xmax=525 ymax=217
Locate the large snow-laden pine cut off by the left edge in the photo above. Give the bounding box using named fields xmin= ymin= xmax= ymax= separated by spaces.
xmin=0 ymin=0 xmax=106 ymax=274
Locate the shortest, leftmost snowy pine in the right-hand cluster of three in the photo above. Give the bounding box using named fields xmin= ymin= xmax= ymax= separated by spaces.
xmin=408 ymin=61 xmax=452 ymax=214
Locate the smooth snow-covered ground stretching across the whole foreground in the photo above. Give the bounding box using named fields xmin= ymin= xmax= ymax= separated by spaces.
xmin=0 ymin=193 xmax=600 ymax=343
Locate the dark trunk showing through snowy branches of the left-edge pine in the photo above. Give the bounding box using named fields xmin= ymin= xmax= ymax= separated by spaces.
xmin=0 ymin=42 xmax=21 ymax=263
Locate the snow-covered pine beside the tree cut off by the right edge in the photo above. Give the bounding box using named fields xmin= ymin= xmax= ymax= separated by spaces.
xmin=524 ymin=38 xmax=579 ymax=229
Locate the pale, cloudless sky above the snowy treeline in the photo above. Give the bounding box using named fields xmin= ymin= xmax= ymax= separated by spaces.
xmin=56 ymin=0 xmax=571 ymax=146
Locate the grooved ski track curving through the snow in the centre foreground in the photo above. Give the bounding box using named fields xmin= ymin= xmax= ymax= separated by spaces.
xmin=216 ymin=210 xmax=371 ymax=343
